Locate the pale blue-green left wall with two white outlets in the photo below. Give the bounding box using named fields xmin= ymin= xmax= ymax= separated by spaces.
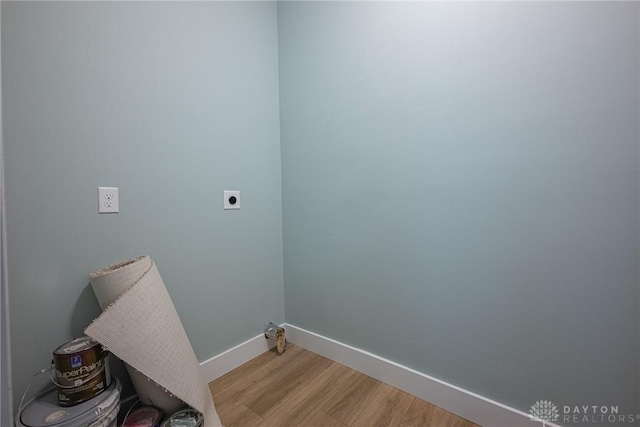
xmin=2 ymin=1 xmax=284 ymax=404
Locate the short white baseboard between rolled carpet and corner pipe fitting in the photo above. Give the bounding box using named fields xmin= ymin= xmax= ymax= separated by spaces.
xmin=200 ymin=334 xmax=275 ymax=383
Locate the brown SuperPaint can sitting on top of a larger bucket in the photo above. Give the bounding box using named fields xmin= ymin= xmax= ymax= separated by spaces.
xmin=51 ymin=336 xmax=111 ymax=407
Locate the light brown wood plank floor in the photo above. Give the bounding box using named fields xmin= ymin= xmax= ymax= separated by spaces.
xmin=209 ymin=344 xmax=477 ymax=427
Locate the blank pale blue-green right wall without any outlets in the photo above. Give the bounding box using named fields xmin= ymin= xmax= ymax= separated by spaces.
xmin=278 ymin=2 xmax=640 ymax=422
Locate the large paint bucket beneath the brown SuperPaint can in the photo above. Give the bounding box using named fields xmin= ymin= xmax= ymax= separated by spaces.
xmin=17 ymin=378 xmax=122 ymax=427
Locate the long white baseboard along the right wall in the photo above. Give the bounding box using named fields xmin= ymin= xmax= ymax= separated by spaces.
xmin=284 ymin=323 xmax=559 ymax=427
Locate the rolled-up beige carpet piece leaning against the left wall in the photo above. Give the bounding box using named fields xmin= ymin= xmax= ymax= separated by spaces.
xmin=85 ymin=255 xmax=222 ymax=427
